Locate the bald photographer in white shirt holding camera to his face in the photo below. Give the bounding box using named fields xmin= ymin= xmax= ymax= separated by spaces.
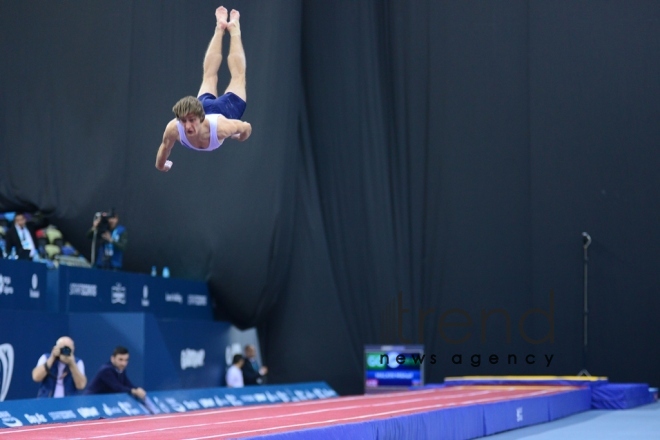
xmin=32 ymin=336 xmax=87 ymax=398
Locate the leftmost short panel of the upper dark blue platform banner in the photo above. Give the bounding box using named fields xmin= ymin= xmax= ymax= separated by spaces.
xmin=0 ymin=259 xmax=50 ymax=311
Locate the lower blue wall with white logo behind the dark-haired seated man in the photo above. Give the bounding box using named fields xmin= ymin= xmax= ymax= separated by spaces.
xmin=68 ymin=313 xmax=230 ymax=390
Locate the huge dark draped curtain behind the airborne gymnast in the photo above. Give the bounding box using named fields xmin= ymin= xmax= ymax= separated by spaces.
xmin=0 ymin=0 xmax=660 ymax=393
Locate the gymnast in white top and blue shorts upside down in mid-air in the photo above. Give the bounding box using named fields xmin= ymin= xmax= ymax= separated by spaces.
xmin=156 ymin=6 xmax=252 ymax=171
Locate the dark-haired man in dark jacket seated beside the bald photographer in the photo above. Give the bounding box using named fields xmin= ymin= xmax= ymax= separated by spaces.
xmin=85 ymin=346 xmax=147 ymax=400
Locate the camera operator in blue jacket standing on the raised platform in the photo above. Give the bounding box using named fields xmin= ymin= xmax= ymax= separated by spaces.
xmin=87 ymin=208 xmax=128 ymax=270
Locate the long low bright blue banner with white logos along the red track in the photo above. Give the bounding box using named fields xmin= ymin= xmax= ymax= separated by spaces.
xmin=0 ymin=382 xmax=337 ymax=428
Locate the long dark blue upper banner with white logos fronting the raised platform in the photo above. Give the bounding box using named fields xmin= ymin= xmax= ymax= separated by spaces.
xmin=0 ymin=260 xmax=213 ymax=321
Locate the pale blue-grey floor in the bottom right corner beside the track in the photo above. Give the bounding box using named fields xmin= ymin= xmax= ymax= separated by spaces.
xmin=482 ymin=402 xmax=660 ymax=440
